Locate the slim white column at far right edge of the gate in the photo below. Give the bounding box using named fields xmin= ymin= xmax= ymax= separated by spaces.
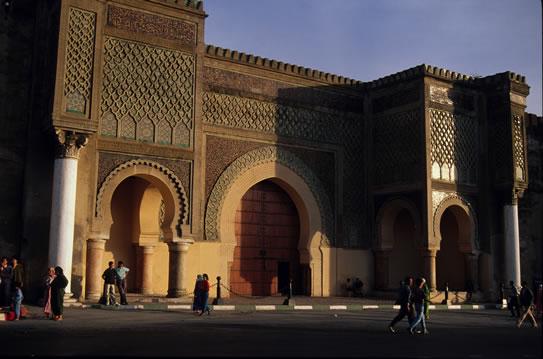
xmin=503 ymin=196 xmax=520 ymax=287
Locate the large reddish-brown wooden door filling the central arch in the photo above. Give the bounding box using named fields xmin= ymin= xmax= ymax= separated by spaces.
xmin=230 ymin=180 xmax=303 ymax=296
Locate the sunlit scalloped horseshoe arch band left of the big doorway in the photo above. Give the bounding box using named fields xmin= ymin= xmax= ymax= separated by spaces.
xmin=93 ymin=159 xmax=188 ymax=240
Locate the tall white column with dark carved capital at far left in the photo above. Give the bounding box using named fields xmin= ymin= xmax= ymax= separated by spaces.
xmin=48 ymin=130 xmax=88 ymax=297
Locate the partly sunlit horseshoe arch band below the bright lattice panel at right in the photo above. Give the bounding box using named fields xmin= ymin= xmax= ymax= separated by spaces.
xmin=428 ymin=195 xmax=479 ymax=254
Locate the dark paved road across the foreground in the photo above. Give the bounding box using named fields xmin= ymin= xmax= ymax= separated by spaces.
xmin=0 ymin=307 xmax=541 ymax=358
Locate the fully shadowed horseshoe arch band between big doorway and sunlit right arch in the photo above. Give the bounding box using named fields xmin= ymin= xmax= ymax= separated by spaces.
xmin=374 ymin=197 xmax=422 ymax=251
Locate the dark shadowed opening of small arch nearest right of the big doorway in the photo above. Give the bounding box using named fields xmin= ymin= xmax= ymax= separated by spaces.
xmin=388 ymin=208 xmax=422 ymax=288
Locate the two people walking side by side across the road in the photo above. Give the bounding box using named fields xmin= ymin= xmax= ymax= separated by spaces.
xmin=388 ymin=276 xmax=430 ymax=334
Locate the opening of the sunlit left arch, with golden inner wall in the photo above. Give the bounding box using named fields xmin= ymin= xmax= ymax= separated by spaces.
xmin=102 ymin=176 xmax=169 ymax=295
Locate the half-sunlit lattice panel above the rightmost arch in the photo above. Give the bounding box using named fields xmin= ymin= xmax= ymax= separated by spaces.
xmin=430 ymin=109 xmax=479 ymax=184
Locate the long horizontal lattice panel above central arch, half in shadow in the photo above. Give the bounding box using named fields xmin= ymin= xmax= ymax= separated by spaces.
xmin=203 ymin=92 xmax=354 ymax=143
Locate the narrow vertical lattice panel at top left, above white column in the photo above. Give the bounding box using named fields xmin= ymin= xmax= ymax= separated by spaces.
xmin=64 ymin=8 xmax=96 ymax=115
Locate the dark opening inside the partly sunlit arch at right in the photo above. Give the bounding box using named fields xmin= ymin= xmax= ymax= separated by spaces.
xmin=436 ymin=206 xmax=471 ymax=291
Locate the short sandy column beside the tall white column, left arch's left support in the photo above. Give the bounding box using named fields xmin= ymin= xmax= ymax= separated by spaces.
xmin=85 ymin=238 xmax=106 ymax=300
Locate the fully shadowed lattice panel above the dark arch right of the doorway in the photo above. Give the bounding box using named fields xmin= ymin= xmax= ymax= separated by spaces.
xmin=373 ymin=109 xmax=422 ymax=184
